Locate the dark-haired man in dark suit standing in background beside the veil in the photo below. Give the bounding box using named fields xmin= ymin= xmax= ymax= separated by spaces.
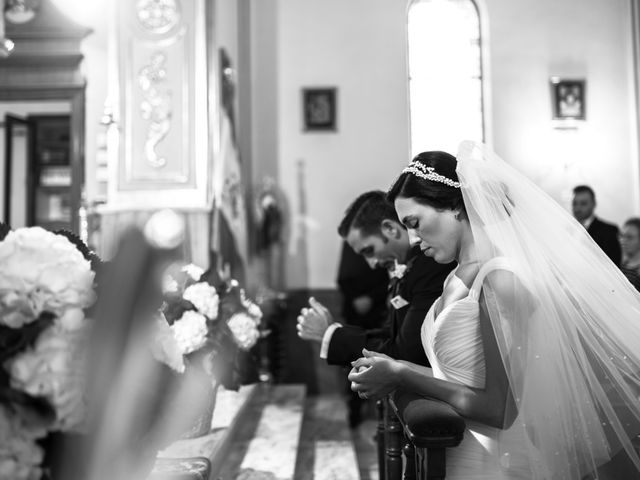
xmin=572 ymin=185 xmax=622 ymax=266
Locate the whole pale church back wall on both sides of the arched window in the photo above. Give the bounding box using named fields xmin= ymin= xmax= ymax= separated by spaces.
xmin=252 ymin=0 xmax=640 ymax=288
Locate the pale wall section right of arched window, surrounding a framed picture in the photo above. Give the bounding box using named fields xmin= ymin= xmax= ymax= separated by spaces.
xmin=484 ymin=0 xmax=640 ymax=224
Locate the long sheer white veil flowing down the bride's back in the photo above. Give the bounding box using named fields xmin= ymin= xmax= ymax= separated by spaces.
xmin=456 ymin=142 xmax=640 ymax=480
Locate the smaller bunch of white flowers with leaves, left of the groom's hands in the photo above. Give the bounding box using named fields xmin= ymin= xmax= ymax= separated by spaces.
xmin=153 ymin=264 xmax=262 ymax=390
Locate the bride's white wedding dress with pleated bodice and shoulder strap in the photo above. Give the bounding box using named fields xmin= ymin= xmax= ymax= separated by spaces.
xmin=422 ymin=259 xmax=533 ymax=480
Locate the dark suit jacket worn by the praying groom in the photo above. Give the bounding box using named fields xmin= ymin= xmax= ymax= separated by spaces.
xmin=327 ymin=247 xmax=455 ymax=365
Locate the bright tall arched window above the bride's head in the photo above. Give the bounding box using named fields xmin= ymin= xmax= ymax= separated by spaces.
xmin=408 ymin=0 xmax=485 ymax=155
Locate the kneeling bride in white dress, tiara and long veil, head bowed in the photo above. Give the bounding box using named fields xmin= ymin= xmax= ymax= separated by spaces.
xmin=349 ymin=142 xmax=640 ymax=480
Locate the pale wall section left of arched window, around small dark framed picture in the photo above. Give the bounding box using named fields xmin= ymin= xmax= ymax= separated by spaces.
xmin=277 ymin=0 xmax=409 ymax=288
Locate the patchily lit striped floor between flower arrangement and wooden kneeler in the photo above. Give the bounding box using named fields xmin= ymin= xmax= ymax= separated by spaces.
xmin=215 ymin=387 xmax=379 ymax=480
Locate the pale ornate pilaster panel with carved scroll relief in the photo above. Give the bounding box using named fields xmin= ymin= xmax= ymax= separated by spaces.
xmin=102 ymin=0 xmax=216 ymax=264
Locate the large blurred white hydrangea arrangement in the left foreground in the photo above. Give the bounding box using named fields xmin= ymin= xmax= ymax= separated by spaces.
xmin=0 ymin=227 xmax=99 ymax=480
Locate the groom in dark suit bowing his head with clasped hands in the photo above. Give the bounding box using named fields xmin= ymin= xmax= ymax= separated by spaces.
xmin=298 ymin=191 xmax=455 ymax=365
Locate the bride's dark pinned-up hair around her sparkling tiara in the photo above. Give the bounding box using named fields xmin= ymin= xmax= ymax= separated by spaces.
xmin=387 ymin=151 xmax=464 ymax=211
